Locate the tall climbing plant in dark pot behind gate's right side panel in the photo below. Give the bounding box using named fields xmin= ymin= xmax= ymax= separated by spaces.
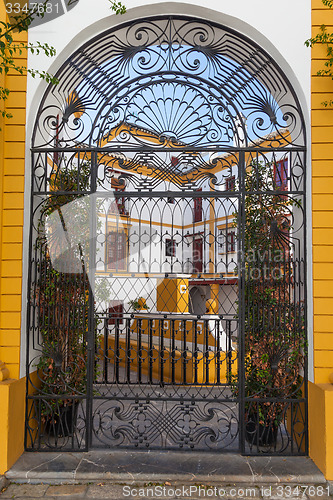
xmin=231 ymin=161 xmax=306 ymax=447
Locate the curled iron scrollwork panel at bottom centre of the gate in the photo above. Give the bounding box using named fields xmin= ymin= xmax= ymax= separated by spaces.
xmin=93 ymin=399 xmax=238 ymax=450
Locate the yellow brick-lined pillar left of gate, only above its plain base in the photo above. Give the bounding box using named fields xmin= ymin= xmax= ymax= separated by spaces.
xmin=0 ymin=2 xmax=27 ymax=379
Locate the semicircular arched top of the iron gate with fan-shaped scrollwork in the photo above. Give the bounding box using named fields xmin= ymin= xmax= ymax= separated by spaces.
xmin=32 ymin=16 xmax=305 ymax=151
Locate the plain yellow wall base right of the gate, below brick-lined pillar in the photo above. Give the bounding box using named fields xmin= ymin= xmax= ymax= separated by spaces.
xmin=309 ymin=382 xmax=333 ymax=481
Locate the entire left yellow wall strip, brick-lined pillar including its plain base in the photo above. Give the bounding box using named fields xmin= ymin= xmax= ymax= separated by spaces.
xmin=0 ymin=2 xmax=27 ymax=474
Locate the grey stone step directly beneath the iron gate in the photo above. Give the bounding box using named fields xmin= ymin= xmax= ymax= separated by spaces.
xmin=6 ymin=450 xmax=326 ymax=485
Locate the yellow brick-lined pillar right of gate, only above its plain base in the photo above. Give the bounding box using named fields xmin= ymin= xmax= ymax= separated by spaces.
xmin=311 ymin=0 xmax=333 ymax=384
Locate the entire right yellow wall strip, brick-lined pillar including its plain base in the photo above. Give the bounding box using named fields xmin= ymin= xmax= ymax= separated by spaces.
xmin=309 ymin=0 xmax=333 ymax=480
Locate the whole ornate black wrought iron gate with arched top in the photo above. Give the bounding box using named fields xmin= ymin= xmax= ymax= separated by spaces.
xmin=26 ymin=16 xmax=307 ymax=454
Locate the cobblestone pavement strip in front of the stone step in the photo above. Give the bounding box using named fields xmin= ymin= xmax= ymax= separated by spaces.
xmin=0 ymin=482 xmax=333 ymax=500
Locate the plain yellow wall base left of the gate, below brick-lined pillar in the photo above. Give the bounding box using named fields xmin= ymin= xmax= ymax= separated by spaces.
xmin=0 ymin=378 xmax=25 ymax=474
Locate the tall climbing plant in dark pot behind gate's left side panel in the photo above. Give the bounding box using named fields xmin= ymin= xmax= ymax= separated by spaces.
xmin=33 ymin=162 xmax=91 ymax=437
